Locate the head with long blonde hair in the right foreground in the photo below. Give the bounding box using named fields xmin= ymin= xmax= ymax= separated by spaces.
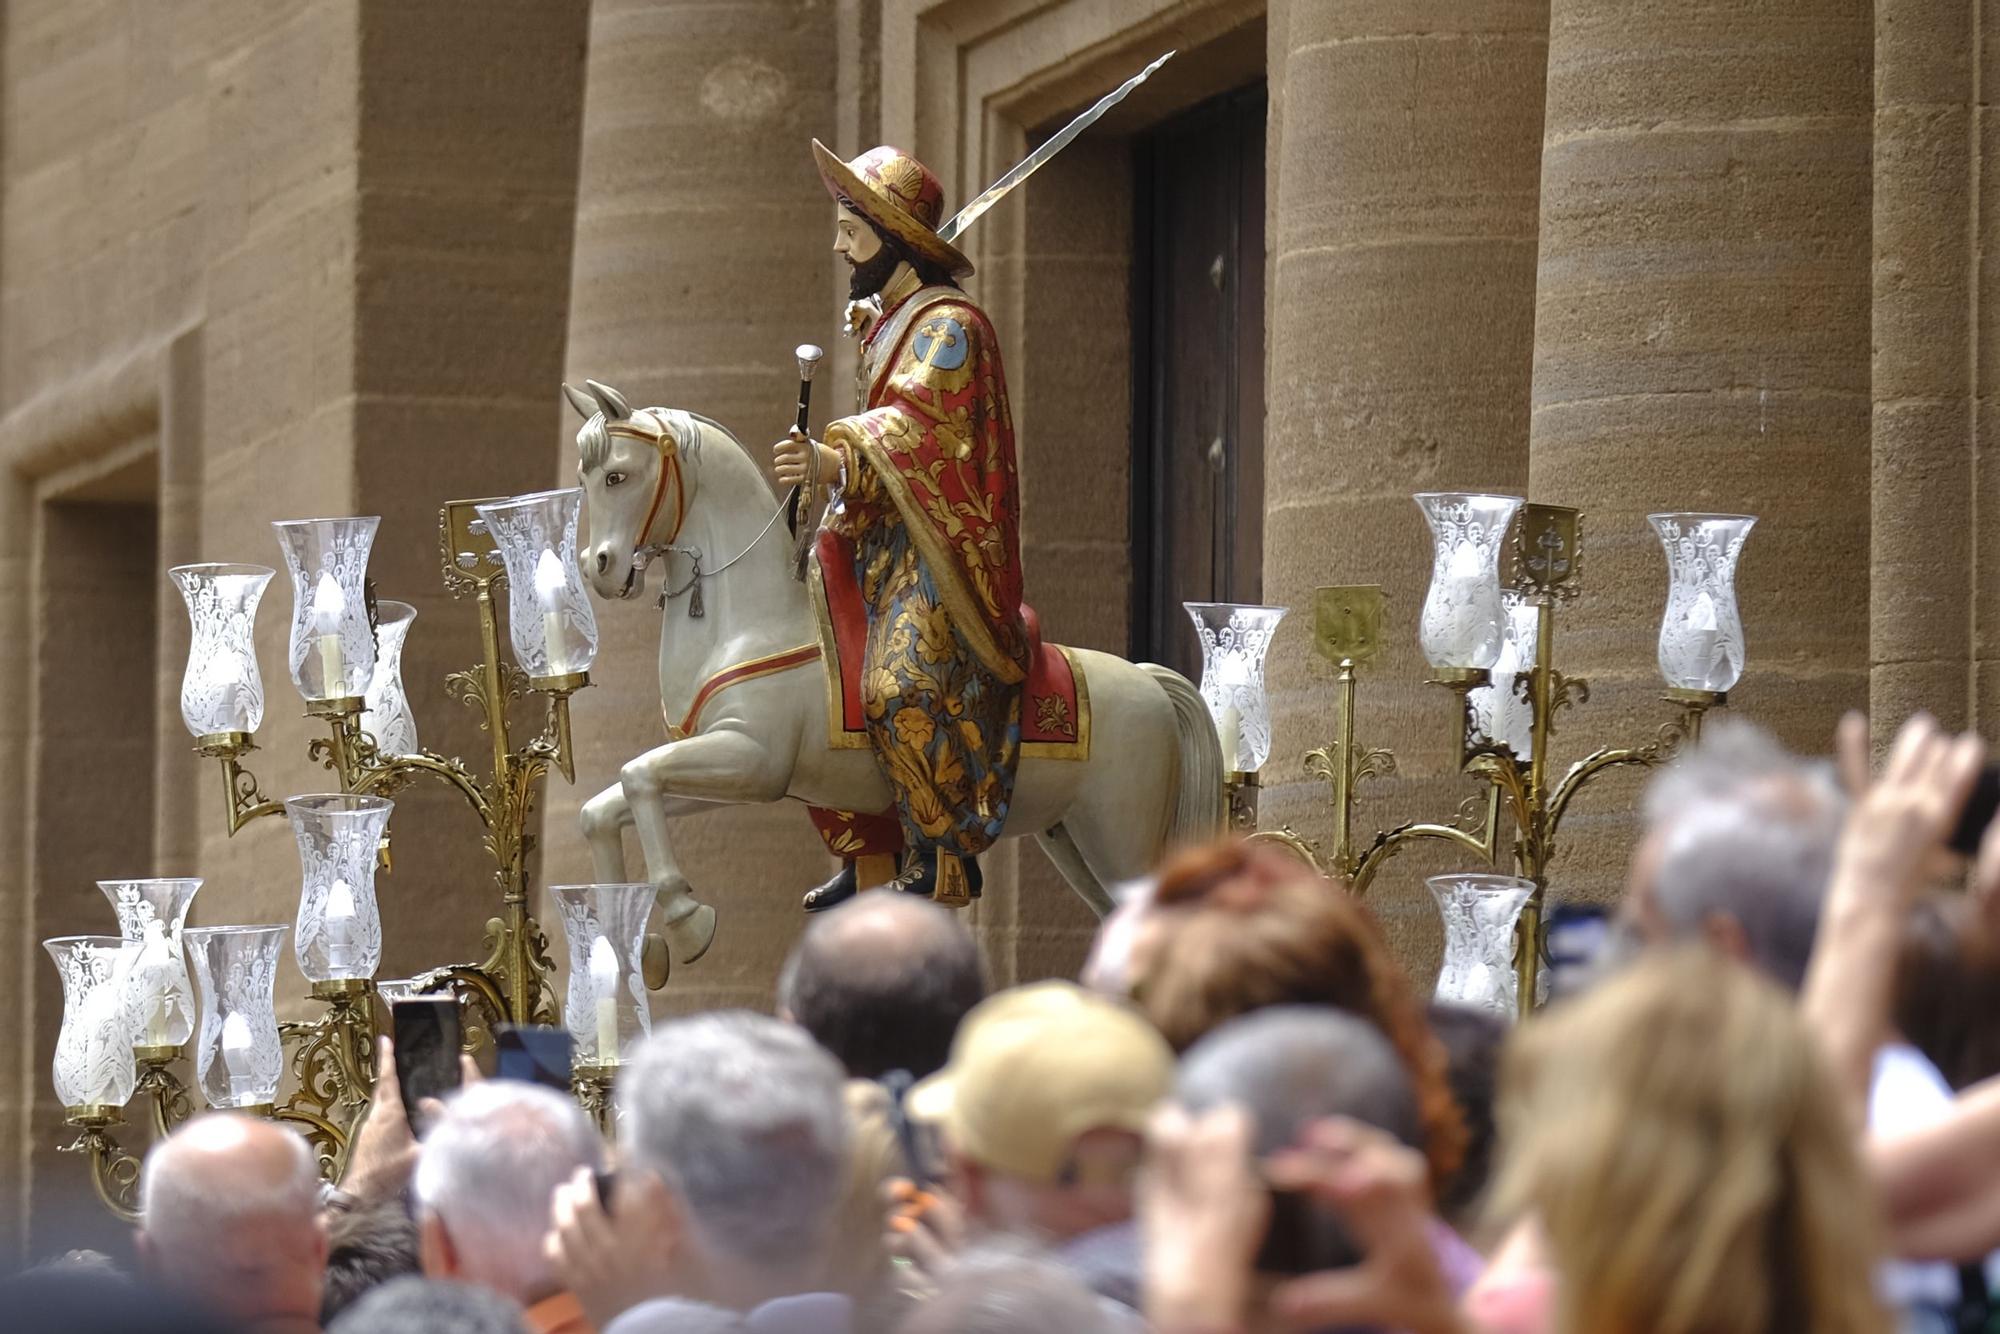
xmin=1494 ymin=948 xmax=1886 ymax=1334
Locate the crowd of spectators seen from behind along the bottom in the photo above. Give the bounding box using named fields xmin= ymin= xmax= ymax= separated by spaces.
xmin=11 ymin=718 xmax=2000 ymax=1334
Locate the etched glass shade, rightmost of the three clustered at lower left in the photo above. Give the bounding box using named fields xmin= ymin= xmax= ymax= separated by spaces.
xmin=184 ymin=926 xmax=284 ymax=1108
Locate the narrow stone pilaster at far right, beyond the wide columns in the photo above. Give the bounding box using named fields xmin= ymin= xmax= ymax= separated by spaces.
xmin=1868 ymin=0 xmax=1980 ymax=742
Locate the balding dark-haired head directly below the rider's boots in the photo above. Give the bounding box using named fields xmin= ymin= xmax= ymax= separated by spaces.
xmin=778 ymin=894 xmax=986 ymax=1080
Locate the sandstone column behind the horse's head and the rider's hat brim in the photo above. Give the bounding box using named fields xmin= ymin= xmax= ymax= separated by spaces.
xmin=544 ymin=0 xmax=858 ymax=1010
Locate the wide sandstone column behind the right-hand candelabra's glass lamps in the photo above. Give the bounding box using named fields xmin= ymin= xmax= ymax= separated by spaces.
xmin=1530 ymin=0 xmax=1872 ymax=900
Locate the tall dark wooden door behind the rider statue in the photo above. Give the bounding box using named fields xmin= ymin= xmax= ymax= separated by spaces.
xmin=1132 ymin=84 xmax=1264 ymax=678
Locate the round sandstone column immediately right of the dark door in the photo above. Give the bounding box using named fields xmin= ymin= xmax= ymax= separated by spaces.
xmin=1264 ymin=0 xmax=1546 ymax=972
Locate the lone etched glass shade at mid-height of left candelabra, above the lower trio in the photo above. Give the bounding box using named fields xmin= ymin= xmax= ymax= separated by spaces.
xmin=284 ymin=792 xmax=396 ymax=982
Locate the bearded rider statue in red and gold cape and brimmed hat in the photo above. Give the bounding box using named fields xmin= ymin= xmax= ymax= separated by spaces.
xmin=774 ymin=140 xmax=1028 ymax=912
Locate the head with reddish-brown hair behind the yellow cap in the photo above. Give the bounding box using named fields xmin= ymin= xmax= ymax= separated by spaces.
xmin=1128 ymin=842 xmax=1464 ymax=1184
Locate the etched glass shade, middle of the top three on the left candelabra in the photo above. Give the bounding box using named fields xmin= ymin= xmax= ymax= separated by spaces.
xmin=272 ymin=516 xmax=382 ymax=700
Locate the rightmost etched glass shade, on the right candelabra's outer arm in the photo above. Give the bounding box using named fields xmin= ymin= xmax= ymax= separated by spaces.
xmin=1646 ymin=514 xmax=1756 ymax=690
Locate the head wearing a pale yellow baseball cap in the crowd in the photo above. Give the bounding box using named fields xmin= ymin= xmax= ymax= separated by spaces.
xmin=908 ymin=982 xmax=1174 ymax=1240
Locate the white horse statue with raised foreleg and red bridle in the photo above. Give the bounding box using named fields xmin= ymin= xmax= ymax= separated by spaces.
xmin=562 ymin=380 xmax=1222 ymax=962
